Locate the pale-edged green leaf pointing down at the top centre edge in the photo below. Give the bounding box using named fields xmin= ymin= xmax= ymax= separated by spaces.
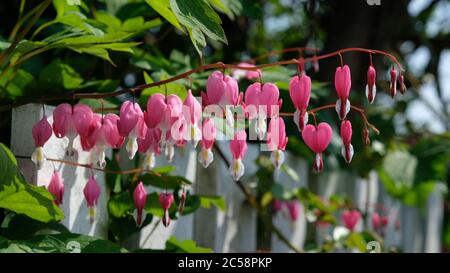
xmin=170 ymin=0 xmax=227 ymax=44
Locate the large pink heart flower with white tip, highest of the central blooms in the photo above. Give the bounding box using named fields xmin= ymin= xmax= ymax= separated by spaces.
xmin=201 ymin=71 xmax=243 ymax=126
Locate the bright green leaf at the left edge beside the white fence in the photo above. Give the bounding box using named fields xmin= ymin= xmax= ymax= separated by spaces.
xmin=0 ymin=143 xmax=64 ymax=222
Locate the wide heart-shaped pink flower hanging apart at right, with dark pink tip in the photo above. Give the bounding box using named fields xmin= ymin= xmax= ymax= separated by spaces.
xmin=302 ymin=122 xmax=333 ymax=172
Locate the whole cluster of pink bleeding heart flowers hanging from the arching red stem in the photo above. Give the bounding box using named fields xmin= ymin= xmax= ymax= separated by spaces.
xmin=32 ymin=56 xmax=406 ymax=225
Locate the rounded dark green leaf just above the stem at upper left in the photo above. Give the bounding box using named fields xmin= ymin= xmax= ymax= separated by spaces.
xmin=39 ymin=59 xmax=84 ymax=90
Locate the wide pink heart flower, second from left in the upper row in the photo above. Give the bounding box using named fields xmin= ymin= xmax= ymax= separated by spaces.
xmin=53 ymin=103 xmax=94 ymax=156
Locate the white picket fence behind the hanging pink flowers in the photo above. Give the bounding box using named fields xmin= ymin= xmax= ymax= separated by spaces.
xmin=11 ymin=104 xmax=443 ymax=252
